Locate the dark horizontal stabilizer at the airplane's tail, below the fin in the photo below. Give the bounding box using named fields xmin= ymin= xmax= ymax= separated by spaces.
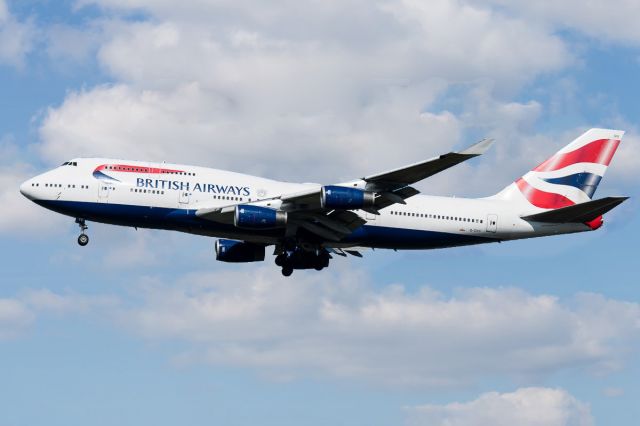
xmin=522 ymin=197 xmax=629 ymax=223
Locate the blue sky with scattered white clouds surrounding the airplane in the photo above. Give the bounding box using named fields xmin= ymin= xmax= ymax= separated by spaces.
xmin=0 ymin=0 xmax=640 ymax=426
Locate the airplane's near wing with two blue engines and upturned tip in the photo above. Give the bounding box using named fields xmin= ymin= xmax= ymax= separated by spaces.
xmin=196 ymin=139 xmax=493 ymax=242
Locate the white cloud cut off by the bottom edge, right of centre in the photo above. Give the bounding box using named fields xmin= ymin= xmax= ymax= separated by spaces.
xmin=407 ymin=388 xmax=594 ymax=426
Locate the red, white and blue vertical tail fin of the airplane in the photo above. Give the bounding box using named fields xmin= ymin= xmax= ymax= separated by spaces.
xmin=494 ymin=129 xmax=624 ymax=210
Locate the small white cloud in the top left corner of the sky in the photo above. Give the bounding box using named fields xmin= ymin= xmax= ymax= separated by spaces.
xmin=0 ymin=0 xmax=36 ymax=67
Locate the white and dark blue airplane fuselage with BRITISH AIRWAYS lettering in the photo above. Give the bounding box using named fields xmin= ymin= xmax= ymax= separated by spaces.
xmin=20 ymin=158 xmax=590 ymax=249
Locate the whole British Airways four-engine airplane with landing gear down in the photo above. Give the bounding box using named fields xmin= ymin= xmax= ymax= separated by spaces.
xmin=20 ymin=129 xmax=628 ymax=276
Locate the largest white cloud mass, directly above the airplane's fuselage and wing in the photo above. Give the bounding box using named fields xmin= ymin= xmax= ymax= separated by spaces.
xmin=36 ymin=0 xmax=571 ymax=182
